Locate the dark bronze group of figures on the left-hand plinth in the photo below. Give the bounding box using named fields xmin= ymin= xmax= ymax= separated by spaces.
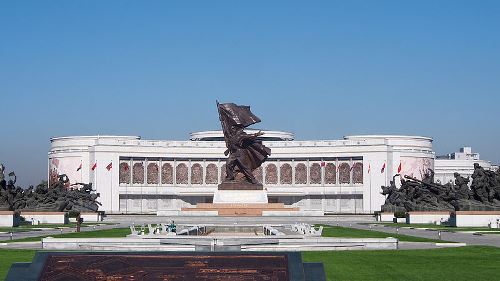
xmin=0 ymin=165 xmax=100 ymax=212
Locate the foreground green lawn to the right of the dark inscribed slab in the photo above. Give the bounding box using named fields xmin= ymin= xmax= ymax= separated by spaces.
xmin=302 ymin=246 xmax=500 ymax=281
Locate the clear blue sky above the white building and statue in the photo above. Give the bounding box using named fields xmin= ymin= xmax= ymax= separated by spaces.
xmin=0 ymin=0 xmax=500 ymax=185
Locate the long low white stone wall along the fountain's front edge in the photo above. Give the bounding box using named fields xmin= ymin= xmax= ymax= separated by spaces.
xmin=42 ymin=236 xmax=398 ymax=252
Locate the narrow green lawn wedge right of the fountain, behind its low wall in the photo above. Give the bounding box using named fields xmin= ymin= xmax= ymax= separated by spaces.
xmin=322 ymin=225 xmax=447 ymax=243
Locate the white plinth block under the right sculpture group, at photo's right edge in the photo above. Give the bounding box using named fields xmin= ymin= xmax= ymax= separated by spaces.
xmin=450 ymin=211 xmax=500 ymax=228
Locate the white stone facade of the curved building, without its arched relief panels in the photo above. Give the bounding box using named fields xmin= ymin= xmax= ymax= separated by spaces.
xmin=49 ymin=133 xmax=434 ymax=213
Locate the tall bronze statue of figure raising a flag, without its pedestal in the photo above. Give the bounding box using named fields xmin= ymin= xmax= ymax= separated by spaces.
xmin=217 ymin=102 xmax=271 ymax=185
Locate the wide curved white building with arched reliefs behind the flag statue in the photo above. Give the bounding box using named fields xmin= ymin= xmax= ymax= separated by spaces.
xmin=49 ymin=130 xmax=446 ymax=213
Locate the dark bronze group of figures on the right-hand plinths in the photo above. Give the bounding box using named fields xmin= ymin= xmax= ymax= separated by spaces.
xmin=382 ymin=163 xmax=500 ymax=212
